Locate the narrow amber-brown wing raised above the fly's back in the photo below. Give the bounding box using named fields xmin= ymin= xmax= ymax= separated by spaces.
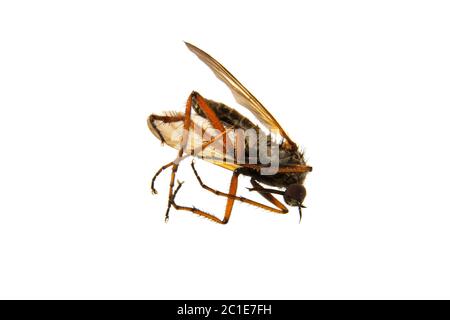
xmin=185 ymin=42 xmax=297 ymax=148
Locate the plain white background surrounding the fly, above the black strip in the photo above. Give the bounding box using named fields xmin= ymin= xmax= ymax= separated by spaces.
xmin=0 ymin=0 xmax=450 ymax=299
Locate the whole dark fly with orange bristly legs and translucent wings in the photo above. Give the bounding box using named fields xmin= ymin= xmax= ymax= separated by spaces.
xmin=147 ymin=42 xmax=312 ymax=224
